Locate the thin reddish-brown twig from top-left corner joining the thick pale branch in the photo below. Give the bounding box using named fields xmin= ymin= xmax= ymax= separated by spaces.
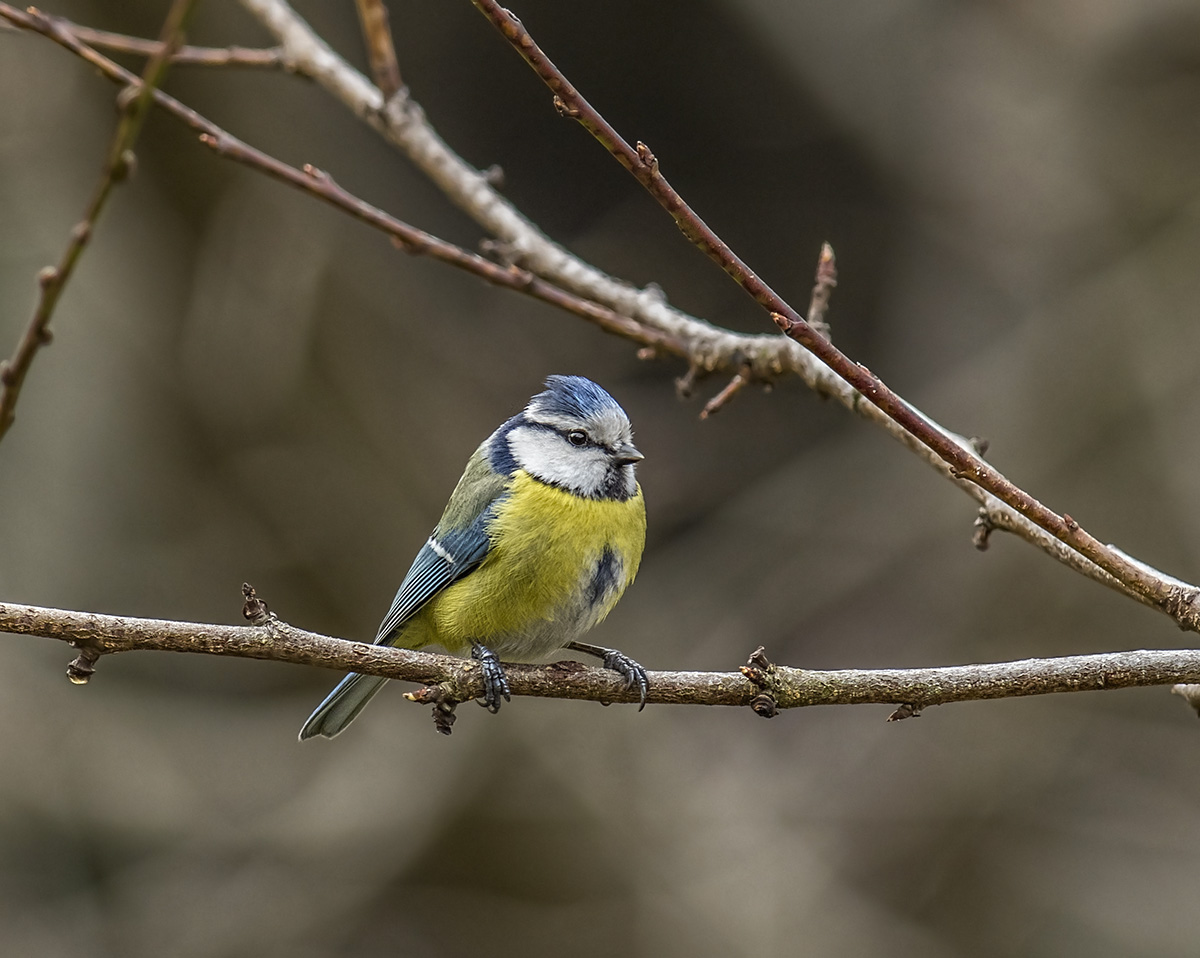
xmin=0 ymin=2 xmax=690 ymax=357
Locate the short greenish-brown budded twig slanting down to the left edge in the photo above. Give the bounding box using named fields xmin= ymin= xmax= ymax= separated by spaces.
xmin=0 ymin=0 xmax=196 ymax=439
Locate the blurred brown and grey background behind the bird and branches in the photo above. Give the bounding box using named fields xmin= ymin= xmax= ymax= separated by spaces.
xmin=0 ymin=0 xmax=1200 ymax=958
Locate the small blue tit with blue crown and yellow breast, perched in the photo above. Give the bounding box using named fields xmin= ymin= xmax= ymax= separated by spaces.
xmin=300 ymin=376 xmax=647 ymax=740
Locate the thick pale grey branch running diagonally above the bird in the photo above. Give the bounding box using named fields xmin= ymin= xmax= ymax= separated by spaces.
xmin=234 ymin=0 xmax=1198 ymax=624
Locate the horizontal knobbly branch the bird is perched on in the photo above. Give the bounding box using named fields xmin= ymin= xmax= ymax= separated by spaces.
xmin=0 ymin=603 xmax=1200 ymax=714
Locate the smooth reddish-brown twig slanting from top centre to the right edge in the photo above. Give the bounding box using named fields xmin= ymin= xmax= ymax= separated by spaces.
xmin=473 ymin=0 xmax=1200 ymax=631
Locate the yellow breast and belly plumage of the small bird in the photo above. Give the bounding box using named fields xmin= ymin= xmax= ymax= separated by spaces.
xmin=402 ymin=471 xmax=646 ymax=657
